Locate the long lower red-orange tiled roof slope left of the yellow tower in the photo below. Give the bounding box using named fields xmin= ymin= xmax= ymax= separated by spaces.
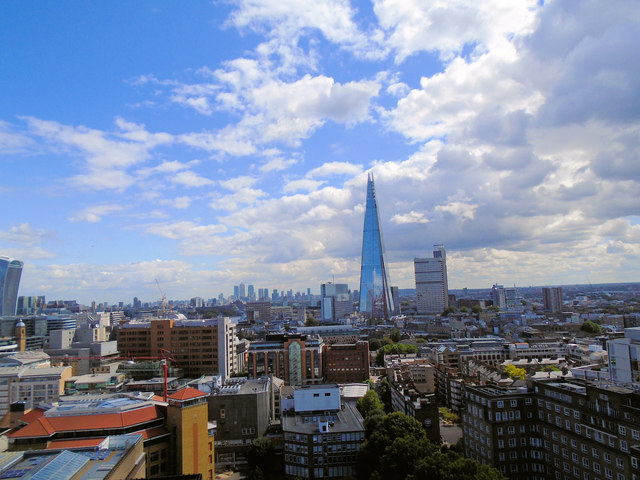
xmin=8 ymin=405 xmax=162 ymax=438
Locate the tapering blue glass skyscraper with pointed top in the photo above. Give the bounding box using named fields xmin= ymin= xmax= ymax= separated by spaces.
xmin=360 ymin=173 xmax=395 ymax=318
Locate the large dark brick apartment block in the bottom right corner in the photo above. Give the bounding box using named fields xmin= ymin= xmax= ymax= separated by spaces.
xmin=463 ymin=378 xmax=640 ymax=480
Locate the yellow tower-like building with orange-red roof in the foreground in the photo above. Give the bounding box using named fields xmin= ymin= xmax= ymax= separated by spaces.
xmin=166 ymin=387 xmax=214 ymax=480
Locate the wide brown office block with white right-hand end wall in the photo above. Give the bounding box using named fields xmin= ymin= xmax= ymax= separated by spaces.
xmin=118 ymin=313 xmax=237 ymax=378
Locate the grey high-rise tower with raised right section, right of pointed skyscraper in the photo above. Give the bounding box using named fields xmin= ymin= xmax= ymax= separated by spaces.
xmin=413 ymin=245 xmax=449 ymax=315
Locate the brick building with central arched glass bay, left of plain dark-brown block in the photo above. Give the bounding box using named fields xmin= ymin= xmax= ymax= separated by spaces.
xmin=247 ymin=334 xmax=324 ymax=385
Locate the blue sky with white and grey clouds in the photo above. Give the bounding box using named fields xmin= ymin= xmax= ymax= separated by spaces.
xmin=0 ymin=0 xmax=640 ymax=304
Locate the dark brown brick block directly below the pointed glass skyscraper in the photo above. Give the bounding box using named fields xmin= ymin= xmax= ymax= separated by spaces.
xmin=322 ymin=342 xmax=371 ymax=383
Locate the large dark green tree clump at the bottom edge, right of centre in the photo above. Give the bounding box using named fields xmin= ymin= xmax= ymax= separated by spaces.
xmin=358 ymin=412 xmax=503 ymax=480
